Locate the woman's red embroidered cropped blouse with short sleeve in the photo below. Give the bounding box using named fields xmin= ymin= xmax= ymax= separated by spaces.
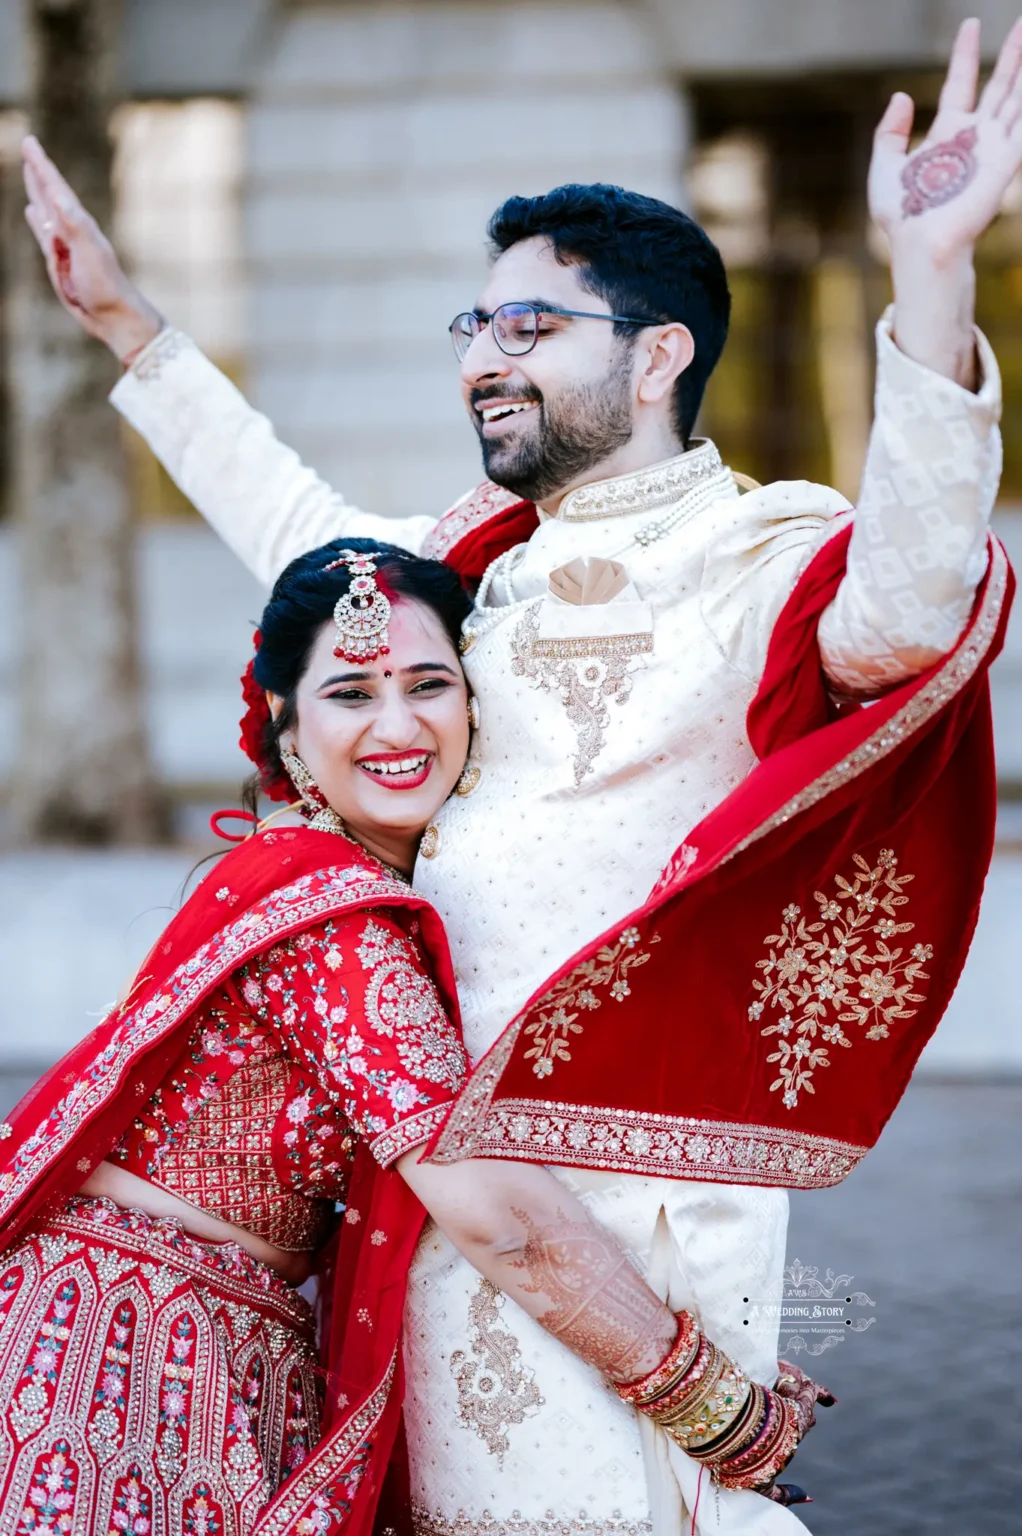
xmin=111 ymin=912 xmax=467 ymax=1252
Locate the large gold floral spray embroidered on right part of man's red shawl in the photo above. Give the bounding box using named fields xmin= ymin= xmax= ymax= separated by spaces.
xmin=748 ymin=848 xmax=933 ymax=1109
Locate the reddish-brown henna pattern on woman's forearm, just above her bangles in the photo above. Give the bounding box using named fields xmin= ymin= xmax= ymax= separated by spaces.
xmin=515 ymin=1210 xmax=678 ymax=1381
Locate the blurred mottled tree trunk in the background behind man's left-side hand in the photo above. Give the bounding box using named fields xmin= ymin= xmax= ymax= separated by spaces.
xmin=8 ymin=0 xmax=160 ymax=843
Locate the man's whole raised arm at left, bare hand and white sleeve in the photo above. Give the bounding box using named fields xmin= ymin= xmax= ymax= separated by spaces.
xmin=22 ymin=138 xmax=435 ymax=582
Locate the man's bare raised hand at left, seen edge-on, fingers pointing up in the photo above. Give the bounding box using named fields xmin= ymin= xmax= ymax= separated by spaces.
xmin=22 ymin=138 xmax=164 ymax=362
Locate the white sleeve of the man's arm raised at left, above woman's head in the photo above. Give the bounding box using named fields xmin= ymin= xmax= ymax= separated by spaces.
xmin=111 ymin=329 xmax=436 ymax=585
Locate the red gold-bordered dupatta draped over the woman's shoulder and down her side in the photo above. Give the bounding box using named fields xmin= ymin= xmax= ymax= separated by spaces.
xmin=0 ymin=828 xmax=460 ymax=1536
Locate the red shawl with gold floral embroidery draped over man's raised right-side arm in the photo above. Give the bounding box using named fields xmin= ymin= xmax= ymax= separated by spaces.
xmin=430 ymin=527 xmax=1013 ymax=1189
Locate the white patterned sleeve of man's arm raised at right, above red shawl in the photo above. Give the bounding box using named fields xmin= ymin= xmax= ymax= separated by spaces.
xmin=819 ymin=310 xmax=1000 ymax=697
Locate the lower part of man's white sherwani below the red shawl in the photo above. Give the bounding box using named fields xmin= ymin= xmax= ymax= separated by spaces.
xmin=404 ymin=1169 xmax=804 ymax=1536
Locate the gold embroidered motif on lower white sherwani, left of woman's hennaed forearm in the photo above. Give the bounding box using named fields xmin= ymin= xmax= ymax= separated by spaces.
xmin=450 ymin=1279 xmax=544 ymax=1465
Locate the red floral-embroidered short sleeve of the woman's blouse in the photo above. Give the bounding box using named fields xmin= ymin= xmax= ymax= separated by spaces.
xmin=246 ymin=911 xmax=469 ymax=1164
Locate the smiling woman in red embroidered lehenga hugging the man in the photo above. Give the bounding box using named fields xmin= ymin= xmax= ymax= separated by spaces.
xmin=0 ymin=539 xmax=827 ymax=1536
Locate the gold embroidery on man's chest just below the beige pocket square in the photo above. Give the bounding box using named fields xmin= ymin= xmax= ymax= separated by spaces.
xmin=512 ymin=607 xmax=653 ymax=785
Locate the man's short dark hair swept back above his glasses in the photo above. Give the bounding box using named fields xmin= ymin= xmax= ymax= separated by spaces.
xmin=487 ymin=181 xmax=732 ymax=444
